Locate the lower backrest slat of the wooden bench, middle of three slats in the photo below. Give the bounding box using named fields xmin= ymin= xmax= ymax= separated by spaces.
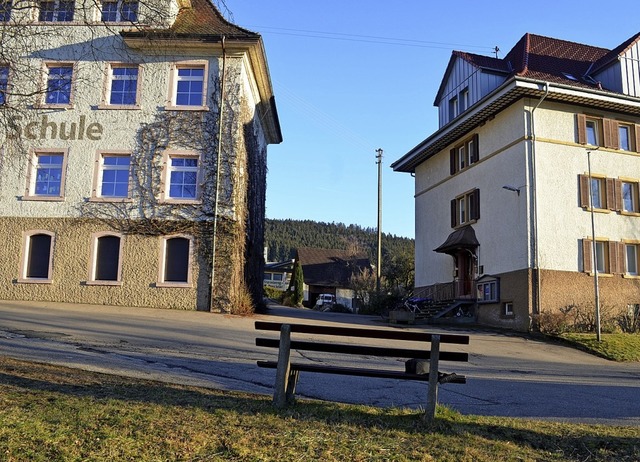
xmin=256 ymin=338 xmax=469 ymax=362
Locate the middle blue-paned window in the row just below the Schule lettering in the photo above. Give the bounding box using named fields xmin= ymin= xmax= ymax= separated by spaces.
xmin=94 ymin=153 xmax=131 ymax=199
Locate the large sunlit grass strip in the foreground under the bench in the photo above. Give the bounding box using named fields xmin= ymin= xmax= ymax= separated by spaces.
xmin=0 ymin=357 xmax=640 ymax=462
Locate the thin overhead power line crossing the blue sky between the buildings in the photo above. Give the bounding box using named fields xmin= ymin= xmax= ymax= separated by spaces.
xmin=244 ymin=26 xmax=495 ymax=53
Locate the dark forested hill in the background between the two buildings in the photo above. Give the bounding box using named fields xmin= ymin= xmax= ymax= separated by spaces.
xmin=265 ymin=219 xmax=414 ymax=263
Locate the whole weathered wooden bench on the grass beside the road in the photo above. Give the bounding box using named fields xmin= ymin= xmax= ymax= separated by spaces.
xmin=255 ymin=321 xmax=469 ymax=420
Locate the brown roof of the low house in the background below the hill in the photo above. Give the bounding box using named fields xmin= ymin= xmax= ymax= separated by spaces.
xmin=297 ymin=247 xmax=371 ymax=287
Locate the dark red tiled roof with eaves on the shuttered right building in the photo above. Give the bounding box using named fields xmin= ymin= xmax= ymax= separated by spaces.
xmin=391 ymin=33 xmax=640 ymax=172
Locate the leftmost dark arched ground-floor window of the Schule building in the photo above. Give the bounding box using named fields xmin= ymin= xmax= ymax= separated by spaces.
xmin=20 ymin=231 xmax=53 ymax=282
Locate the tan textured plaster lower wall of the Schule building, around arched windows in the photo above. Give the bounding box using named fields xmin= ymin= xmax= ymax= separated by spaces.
xmin=0 ymin=218 xmax=202 ymax=310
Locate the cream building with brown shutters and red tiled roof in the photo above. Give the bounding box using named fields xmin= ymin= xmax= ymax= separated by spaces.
xmin=392 ymin=30 xmax=640 ymax=330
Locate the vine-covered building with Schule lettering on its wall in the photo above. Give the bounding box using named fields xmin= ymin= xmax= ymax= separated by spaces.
xmin=0 ymin=0 xmax=282 ymax=312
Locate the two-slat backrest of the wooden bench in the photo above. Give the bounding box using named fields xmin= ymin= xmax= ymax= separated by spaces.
xmin=255 ymin=321 xmax=469 ymax=362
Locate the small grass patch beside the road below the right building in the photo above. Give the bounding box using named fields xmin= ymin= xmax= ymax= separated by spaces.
xmin=560 ymin=333 xmax=640 ymax=362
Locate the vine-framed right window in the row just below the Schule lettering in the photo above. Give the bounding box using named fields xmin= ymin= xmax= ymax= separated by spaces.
xmin=164 ymin=154 xmax=200 ymax=201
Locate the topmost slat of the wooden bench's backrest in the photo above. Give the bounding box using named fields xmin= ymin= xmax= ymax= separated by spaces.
xmin=255 ymin=321 xmax=469 ymax=345
